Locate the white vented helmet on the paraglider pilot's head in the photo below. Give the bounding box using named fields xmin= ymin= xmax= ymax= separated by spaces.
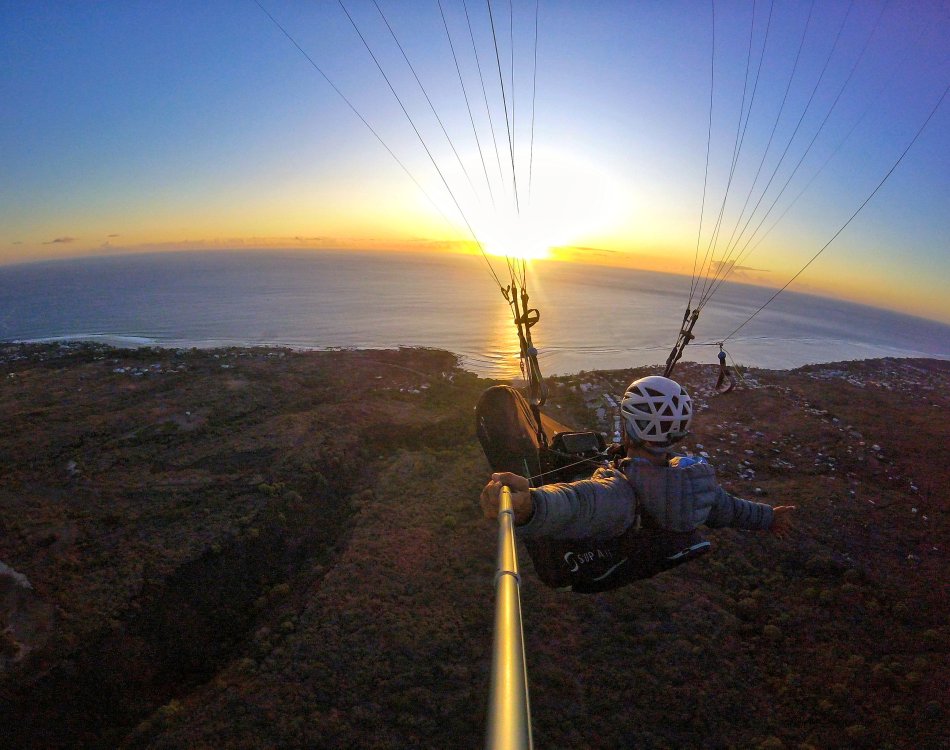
xmin=620 ymin=375 xmax=693 ymax=445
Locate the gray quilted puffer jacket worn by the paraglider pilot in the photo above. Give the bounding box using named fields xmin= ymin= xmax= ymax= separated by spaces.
xmin=517 ymin=460 xmax=772 ymax=539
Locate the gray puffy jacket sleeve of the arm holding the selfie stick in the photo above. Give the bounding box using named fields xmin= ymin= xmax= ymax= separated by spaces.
xmin=517 ymin=469 xmax=637 ymax=539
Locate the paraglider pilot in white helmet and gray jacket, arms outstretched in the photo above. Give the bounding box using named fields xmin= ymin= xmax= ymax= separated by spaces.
xmin=481 ymin=375 xmax=795 ymax=591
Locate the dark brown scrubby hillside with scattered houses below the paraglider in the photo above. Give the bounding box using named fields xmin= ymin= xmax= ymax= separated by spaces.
xmin=0 ymin=344 xmax=950 ymax=750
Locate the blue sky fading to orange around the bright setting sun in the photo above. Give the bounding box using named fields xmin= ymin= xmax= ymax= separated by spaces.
xmin=0 ymin=0 xmax=950 ymax=322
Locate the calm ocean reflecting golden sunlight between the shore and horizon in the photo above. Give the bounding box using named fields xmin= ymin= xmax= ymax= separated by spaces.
xmin=0 ymin=251 xmax=950 ymax=377
